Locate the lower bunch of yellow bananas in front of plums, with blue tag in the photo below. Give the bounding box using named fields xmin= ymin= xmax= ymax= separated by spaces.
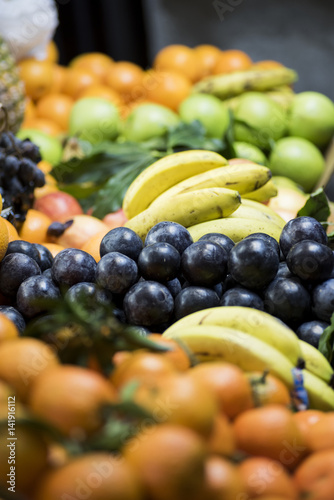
xmin=163 ymin=306 xmax=334 ymax=411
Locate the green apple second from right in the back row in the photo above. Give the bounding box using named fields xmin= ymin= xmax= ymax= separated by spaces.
xmin=234 ymin=92 xmax=287 ymax=149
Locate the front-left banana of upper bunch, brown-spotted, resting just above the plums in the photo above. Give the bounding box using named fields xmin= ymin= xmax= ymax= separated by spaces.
xmin=124 ymin=188 xmax=241 ymax=240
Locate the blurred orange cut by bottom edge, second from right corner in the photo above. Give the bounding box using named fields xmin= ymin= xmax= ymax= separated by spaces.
xmin=239 ymin=457 xmax=297 ymax=500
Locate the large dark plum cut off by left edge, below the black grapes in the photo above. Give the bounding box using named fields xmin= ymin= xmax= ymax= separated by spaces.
xmin=0 ymin=253 xmax=41 ymax=299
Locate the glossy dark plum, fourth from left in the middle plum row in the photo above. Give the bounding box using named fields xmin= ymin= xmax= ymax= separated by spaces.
xmin=138 ymin=242 xmax=181 ymax=283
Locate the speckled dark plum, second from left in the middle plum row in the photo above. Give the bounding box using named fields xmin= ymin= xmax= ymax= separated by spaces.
xmin=51 ymin=248 xmax=97 ymax=287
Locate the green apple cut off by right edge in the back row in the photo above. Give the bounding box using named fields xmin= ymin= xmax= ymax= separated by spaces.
xmin=288 ymin=92 xmax=334 ymax=148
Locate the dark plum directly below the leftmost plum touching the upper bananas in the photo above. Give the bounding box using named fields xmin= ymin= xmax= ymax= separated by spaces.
xmin=96 ymin=252 xmax=138 ymax=294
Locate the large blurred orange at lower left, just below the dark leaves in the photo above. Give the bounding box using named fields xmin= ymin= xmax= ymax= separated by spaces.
xmin=29 ymin=365 xmax=117 ymax=438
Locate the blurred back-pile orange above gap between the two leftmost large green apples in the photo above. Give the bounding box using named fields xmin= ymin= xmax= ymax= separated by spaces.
xmin=105 ymin=61 xmax=145 ymax=102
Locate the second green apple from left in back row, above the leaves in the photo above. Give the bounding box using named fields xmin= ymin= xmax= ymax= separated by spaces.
xmin=123 ymin=103 xmax=180 ymax=142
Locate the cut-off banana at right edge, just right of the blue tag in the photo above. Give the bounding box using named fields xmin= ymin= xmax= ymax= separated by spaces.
xmin=303 ymin=370 xmax=334 ymax=411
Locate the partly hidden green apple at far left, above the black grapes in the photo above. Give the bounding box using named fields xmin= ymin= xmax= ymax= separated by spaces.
xmin=16 ymin=128 xmax=63 ymax=165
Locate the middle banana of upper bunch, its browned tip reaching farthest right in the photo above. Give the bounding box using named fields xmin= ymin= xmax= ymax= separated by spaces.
xmin=150 ymin=162 xmax=271 ymax=207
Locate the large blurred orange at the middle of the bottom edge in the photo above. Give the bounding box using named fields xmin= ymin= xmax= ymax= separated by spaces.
xmin=122 ymin=422 xmax=206 ymax=500
